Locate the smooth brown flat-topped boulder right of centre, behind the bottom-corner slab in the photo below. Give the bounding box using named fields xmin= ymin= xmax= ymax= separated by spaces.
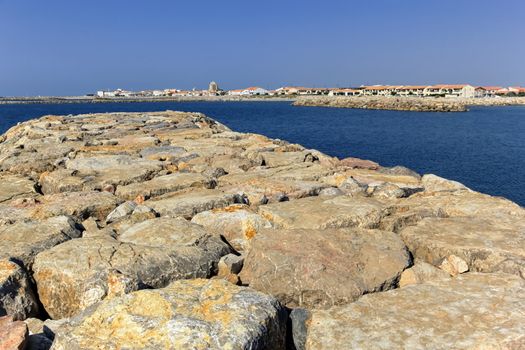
xmin=241 ymin=228 xmax=410 ymax=308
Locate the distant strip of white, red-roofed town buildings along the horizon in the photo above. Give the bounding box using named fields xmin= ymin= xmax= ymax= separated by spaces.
xmin=95 ymin=81 xmax=525 ymax=98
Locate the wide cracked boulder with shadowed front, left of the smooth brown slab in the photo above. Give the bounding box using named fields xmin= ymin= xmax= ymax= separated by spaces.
xmin=33 ymin=218 xmax=230 ymax=318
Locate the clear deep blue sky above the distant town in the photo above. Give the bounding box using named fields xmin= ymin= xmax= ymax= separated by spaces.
xmin=0 ymin=0 xmax=525 ymax=96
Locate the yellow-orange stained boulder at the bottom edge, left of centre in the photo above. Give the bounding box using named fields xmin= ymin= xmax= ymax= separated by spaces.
xmin=53 ymin=279 xmax=286 ymax=350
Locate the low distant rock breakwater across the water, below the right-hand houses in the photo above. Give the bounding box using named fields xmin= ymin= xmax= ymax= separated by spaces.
xmin=294 ymin=96 xmax=525 ymax=112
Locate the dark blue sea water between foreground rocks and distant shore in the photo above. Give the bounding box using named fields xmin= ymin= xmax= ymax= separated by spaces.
xmin=0 ymin=102 xmax=525 ymax=206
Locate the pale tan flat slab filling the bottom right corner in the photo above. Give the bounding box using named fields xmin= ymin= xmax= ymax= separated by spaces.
xmin=306 ymin=273 xmax=525 ymax=349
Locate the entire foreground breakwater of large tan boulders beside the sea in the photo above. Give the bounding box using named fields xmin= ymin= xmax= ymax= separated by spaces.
xmin=0 ymin=111 xmax=525 ymax=350
